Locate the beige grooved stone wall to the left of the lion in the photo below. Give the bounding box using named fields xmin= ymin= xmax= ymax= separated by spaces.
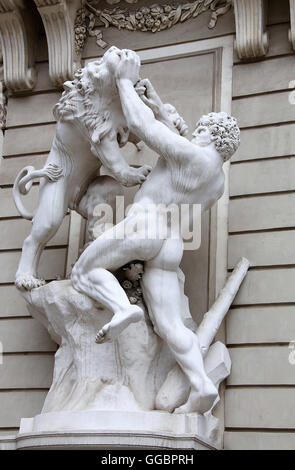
xmin=0 ymin=31 xmax=61 ymax=434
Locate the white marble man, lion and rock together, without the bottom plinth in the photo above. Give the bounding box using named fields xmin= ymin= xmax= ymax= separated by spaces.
xmin=14 ymin=47 xmax=248 ymax=440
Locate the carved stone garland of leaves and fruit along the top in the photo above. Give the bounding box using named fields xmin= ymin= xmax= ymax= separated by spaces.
xmin=75 ymin=0 xmax=232 ymax=51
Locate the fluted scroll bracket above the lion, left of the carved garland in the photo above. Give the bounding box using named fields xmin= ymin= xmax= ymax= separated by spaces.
xmin=34 ymin=0 xmax=81 ymax=87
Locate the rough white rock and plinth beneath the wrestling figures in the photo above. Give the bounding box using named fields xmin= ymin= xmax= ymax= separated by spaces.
xmin=0 ymin=280 xmax=234 ymax=449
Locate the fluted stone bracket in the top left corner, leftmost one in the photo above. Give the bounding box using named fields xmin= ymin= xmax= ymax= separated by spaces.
xmin=0 ymin=0 xmax=36 ymax=92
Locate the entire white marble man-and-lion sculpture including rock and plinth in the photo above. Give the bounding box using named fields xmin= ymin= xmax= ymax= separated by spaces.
xmin=10 ymin=47 xmax=249 ymax=445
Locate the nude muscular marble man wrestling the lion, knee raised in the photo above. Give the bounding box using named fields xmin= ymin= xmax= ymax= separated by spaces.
xmin=72 ymin=50 xmax=239 ymax=413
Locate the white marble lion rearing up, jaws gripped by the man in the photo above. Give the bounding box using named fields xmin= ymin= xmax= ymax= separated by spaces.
xmin=13 ymin=47 xmax=151 ymax=290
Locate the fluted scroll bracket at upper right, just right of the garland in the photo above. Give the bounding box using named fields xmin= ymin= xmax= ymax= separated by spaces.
xmin=233 ymin=0 xmax=268 ymax=60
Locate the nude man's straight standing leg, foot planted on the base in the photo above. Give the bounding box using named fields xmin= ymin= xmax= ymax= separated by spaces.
xmin=141 ymin=240 xmax=217 ymax=413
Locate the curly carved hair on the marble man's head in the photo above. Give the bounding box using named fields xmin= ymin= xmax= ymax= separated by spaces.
xmin=196 ymin=112 xmax=240 ymax=162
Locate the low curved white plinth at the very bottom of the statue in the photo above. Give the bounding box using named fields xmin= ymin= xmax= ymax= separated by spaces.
xmin=6 ymin=411 xmax=218 ymax=450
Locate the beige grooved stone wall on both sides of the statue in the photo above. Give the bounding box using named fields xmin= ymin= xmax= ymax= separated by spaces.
xmin=0 ymin=0 xmax=295 ymax=449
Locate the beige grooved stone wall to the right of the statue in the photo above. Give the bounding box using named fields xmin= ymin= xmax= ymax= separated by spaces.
xmin=225 ymin=2 xmax=295 ymax=449
